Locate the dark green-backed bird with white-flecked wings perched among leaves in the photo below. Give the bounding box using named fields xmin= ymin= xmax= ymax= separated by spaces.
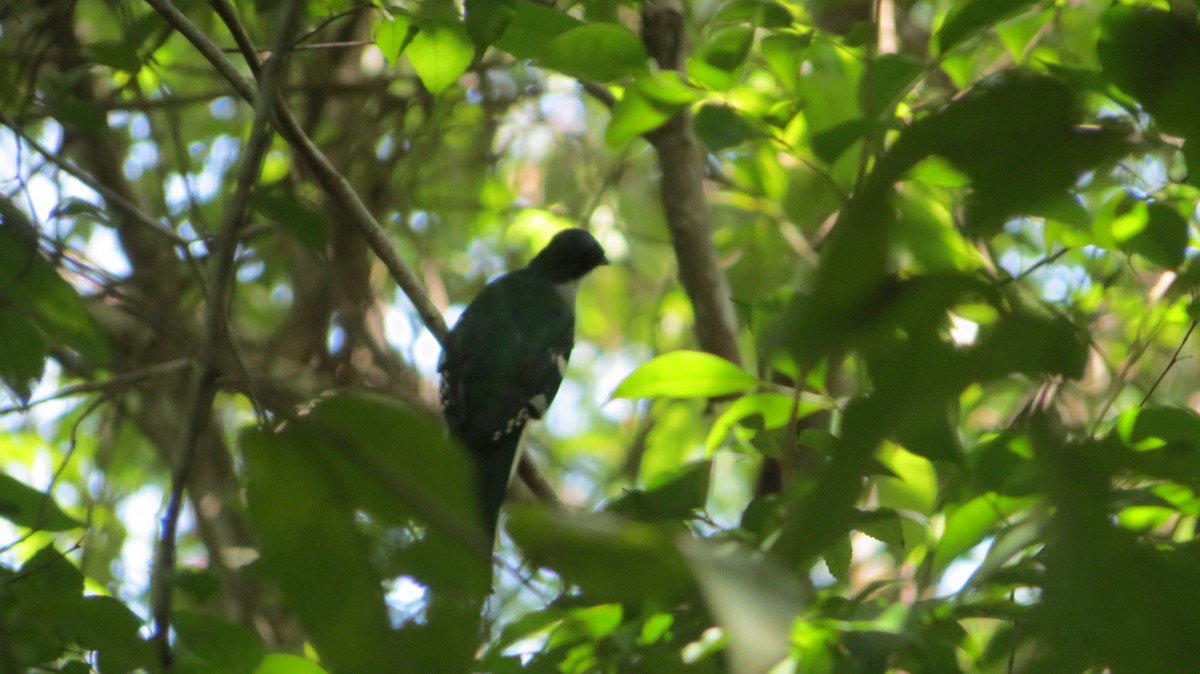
xmin=438 ymin=229 xmax=608 ymax=542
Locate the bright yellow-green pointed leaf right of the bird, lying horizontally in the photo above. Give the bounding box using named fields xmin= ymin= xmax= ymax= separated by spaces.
xmin=612 ymin=351 xmax=758 ymax=398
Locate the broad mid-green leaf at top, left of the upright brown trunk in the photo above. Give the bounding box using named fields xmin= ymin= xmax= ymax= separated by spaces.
xmin=538 ymin=23 xmax=649 ymax=82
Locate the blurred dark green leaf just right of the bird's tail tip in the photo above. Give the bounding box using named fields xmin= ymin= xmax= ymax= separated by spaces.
xmin=506 ymin=506 xmax=691 ymax=602
